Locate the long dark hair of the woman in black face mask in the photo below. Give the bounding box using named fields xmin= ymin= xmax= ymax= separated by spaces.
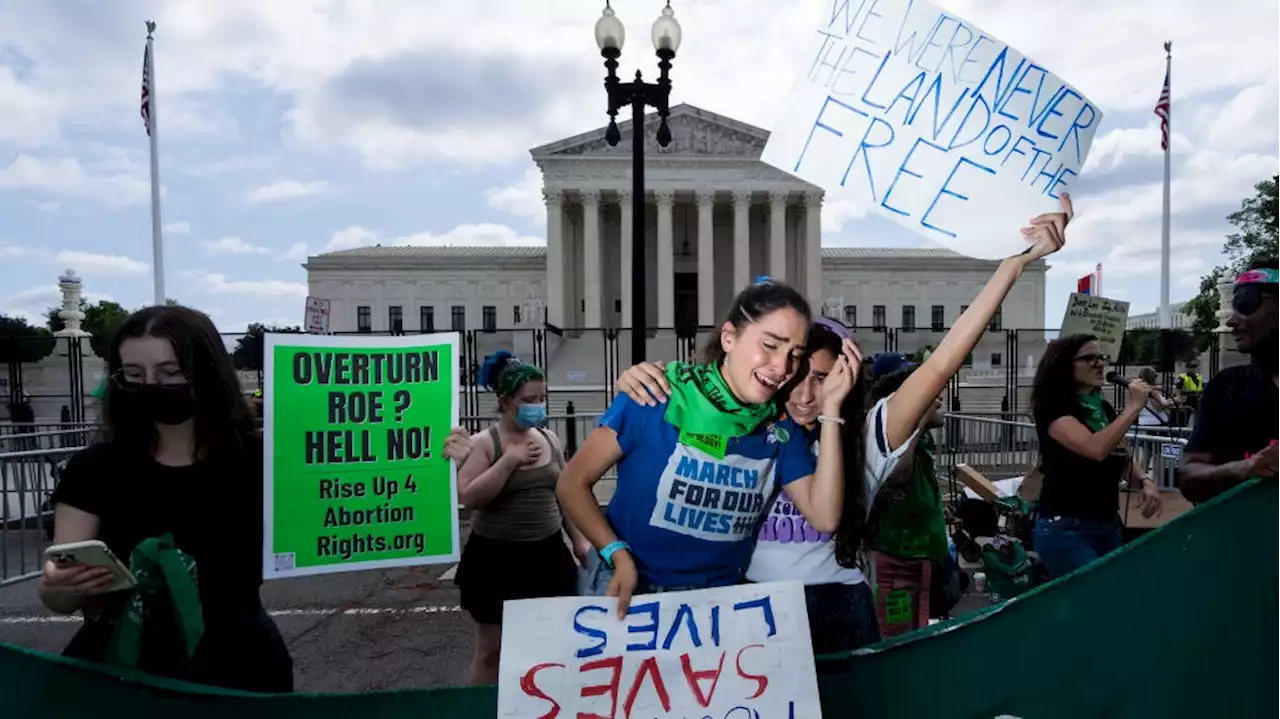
xmin=104 ymin=306 xmax=257 ymax=458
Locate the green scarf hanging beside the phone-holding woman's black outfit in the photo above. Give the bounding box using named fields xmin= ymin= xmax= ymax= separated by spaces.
xmin=106 ymin=533 xmax=205 ymax=668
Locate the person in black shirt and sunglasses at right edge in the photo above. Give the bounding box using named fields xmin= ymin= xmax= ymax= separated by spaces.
xmin=1178 ymin=260 xmax=1280 ymax=503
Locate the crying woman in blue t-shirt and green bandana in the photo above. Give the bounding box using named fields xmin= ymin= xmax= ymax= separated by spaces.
xmin=558 ymin=281 xmax=859 ymax=617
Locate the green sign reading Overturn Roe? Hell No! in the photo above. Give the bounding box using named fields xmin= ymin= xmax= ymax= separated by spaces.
xmin=262 ymin=333 xmax=460 ymax=578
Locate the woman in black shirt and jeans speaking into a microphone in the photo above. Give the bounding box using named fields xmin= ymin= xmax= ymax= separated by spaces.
xmin=1032 ymin=334 xmax=1161 ymax=577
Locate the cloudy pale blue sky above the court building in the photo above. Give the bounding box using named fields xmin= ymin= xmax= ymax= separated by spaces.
xmin=0 ymin=0 xmax=1280 ymax=331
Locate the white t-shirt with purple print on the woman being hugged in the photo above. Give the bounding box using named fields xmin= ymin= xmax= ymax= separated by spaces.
xmin=746 ymin=395 xmax=915 ymax=585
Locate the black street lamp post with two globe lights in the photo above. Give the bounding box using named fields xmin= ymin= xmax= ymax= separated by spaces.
xmin=595 ymin=0 xmax=680 ymax=365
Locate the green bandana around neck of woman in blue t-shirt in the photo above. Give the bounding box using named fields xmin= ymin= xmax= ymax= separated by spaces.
xmin=663 ymin=362 xmax=774 ymax=438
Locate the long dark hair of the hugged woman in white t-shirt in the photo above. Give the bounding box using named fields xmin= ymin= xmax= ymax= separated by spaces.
xmin=788 ymin=320 xmax=868 ymax=568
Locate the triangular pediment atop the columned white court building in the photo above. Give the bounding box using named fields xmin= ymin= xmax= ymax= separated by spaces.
xmin=530 ymin=104 xmax=769 ymax=162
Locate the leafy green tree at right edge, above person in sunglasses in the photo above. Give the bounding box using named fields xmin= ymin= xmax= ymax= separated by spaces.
xmin=1183 ymin=175 xmax=1280 ymax=331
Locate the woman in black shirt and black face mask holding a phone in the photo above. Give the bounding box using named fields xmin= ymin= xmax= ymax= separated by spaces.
xmin=38 ymin=306 xmax=293 ymax=692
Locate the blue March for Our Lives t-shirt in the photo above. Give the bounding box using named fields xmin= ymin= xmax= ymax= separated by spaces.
xmin=599 ymin=395 xmax=817 ymax=587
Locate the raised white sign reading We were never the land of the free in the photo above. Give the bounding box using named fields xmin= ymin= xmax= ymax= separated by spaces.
xmin=762 ymin=0 xmax=1102 ymax=260
